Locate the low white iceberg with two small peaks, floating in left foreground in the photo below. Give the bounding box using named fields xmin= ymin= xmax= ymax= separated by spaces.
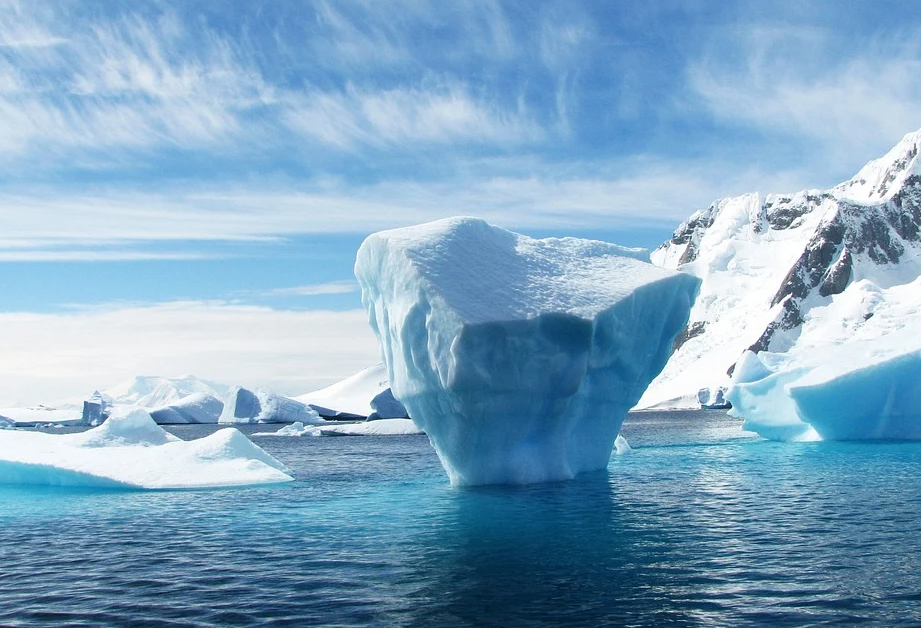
xmin=0 ymin=407 xmax=293 ymax=489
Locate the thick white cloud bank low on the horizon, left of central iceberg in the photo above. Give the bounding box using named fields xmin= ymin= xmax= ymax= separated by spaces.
xmin=0 ymin=301 xmax=380 ymax=407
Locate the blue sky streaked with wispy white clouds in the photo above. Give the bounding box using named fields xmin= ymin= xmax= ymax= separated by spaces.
xmin=0 ymin=0 xmax=921 ymax=406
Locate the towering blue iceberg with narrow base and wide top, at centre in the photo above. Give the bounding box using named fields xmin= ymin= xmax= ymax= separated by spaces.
xmin=355 ymin=218 xmax=700 ymax=485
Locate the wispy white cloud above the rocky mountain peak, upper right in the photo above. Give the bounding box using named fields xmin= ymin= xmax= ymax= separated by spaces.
xmin=688 ymin=27 xmax=921 ymax=171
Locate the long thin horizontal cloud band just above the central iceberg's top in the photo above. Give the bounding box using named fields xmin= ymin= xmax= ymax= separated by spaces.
xmin=0 ymin=155 xmax=820 ymax=260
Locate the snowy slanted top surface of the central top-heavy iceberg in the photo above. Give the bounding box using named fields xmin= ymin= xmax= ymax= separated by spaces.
xmin=359 ymin=217 xmax=663 ymax=325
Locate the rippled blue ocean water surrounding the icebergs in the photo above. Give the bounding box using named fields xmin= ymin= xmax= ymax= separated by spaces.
xmin=0 ymin=412 xmax=921 ymax=627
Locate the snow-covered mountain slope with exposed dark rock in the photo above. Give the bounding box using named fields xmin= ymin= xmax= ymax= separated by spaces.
xmin=637 ymin=131 xmax=921 ymax=407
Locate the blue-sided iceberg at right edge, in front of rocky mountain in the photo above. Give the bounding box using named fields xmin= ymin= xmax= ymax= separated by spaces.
xmin=727 ymin=279 xmax=921 ymax=440
